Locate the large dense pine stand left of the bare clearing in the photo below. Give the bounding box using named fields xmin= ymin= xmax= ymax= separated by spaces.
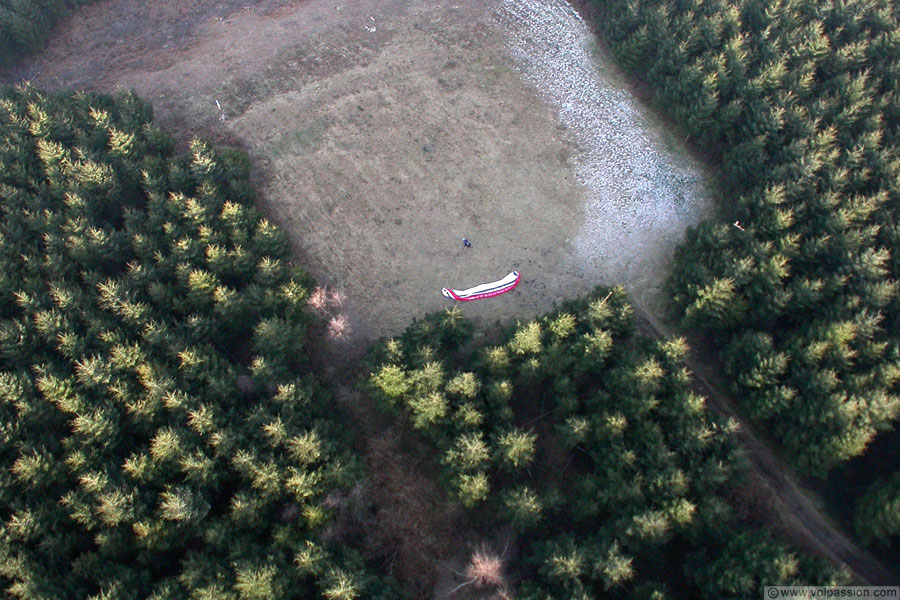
xmin=0 ymin=88 xmax=398 ymax=600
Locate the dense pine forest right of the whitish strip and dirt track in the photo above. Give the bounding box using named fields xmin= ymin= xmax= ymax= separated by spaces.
xmin=596 ymin=0 xmax=900 ymax=539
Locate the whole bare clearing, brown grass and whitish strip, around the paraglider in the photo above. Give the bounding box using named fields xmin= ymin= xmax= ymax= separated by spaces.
xmin=8 ymin=0 xmax=710 ymax=348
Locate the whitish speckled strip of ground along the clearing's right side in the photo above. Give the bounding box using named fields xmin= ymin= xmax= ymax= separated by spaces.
xmin=497 ymin=0 xmax=712 ymax=316
